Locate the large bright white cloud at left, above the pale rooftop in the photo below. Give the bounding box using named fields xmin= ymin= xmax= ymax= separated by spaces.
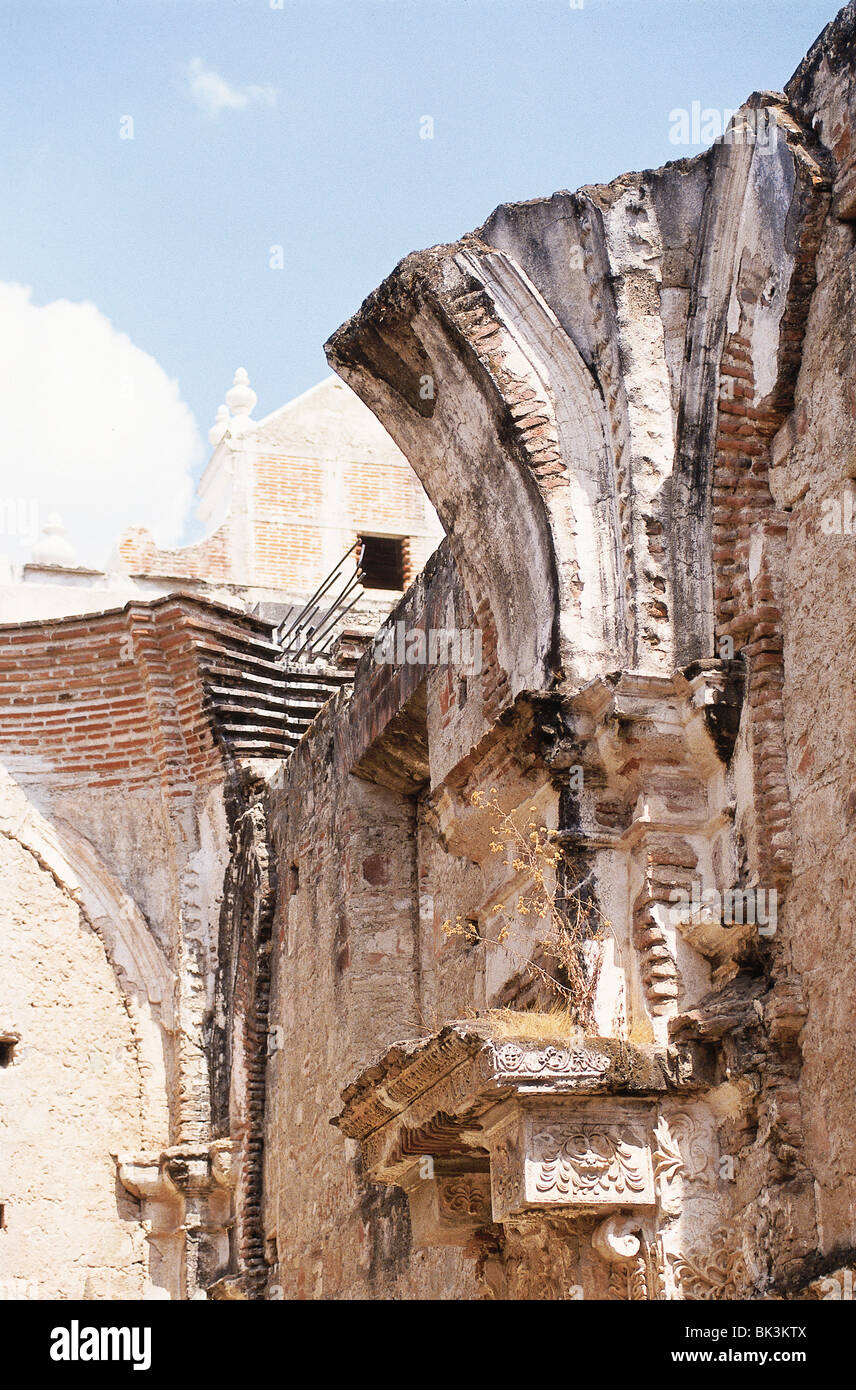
xmin=0 ymin=284 xmax=203 ymax=567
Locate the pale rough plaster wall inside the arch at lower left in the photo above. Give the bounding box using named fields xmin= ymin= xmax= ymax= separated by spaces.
xmin=0 ymin=835 xmax=147 ymax=1298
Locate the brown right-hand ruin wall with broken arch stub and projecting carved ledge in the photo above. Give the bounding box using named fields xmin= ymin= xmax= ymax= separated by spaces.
xmin=257 ymin=6 xmax=856 ymax=1298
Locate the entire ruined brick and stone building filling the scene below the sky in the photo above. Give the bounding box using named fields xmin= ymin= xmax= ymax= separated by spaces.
xmin=0 ymin=4 xmax=856 ymax=1300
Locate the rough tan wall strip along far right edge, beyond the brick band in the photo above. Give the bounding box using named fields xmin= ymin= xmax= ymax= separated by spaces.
xmin=771 ymin=4 xmax=856 ymax=1273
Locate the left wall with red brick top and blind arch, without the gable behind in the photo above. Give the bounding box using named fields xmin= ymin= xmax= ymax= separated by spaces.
xmin=0 ymin=600 xmax=282 ymax=1297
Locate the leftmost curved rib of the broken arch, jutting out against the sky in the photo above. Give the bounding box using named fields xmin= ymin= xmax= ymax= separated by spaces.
xmin=327 ymin=239 xmax=623 ymax=695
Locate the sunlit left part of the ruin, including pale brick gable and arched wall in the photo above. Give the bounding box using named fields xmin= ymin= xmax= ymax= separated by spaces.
xmin=0 ymin=371 xmax=442 ymax=1298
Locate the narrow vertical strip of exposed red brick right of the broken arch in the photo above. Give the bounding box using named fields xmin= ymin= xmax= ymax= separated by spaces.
xmin=713 ymin=154 xmax=828 ymax=888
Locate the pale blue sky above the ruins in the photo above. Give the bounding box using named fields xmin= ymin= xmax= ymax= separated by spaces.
xmin=0 ymin=0 xmax=838 ymax=564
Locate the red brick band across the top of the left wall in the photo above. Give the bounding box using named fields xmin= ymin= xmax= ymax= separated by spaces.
xmin=0 ymin=598 xmax=282 ymax=798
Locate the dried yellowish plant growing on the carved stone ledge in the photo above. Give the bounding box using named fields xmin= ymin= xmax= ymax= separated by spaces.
xmin=443 ymin=787 xmax=610 ymax=1027
